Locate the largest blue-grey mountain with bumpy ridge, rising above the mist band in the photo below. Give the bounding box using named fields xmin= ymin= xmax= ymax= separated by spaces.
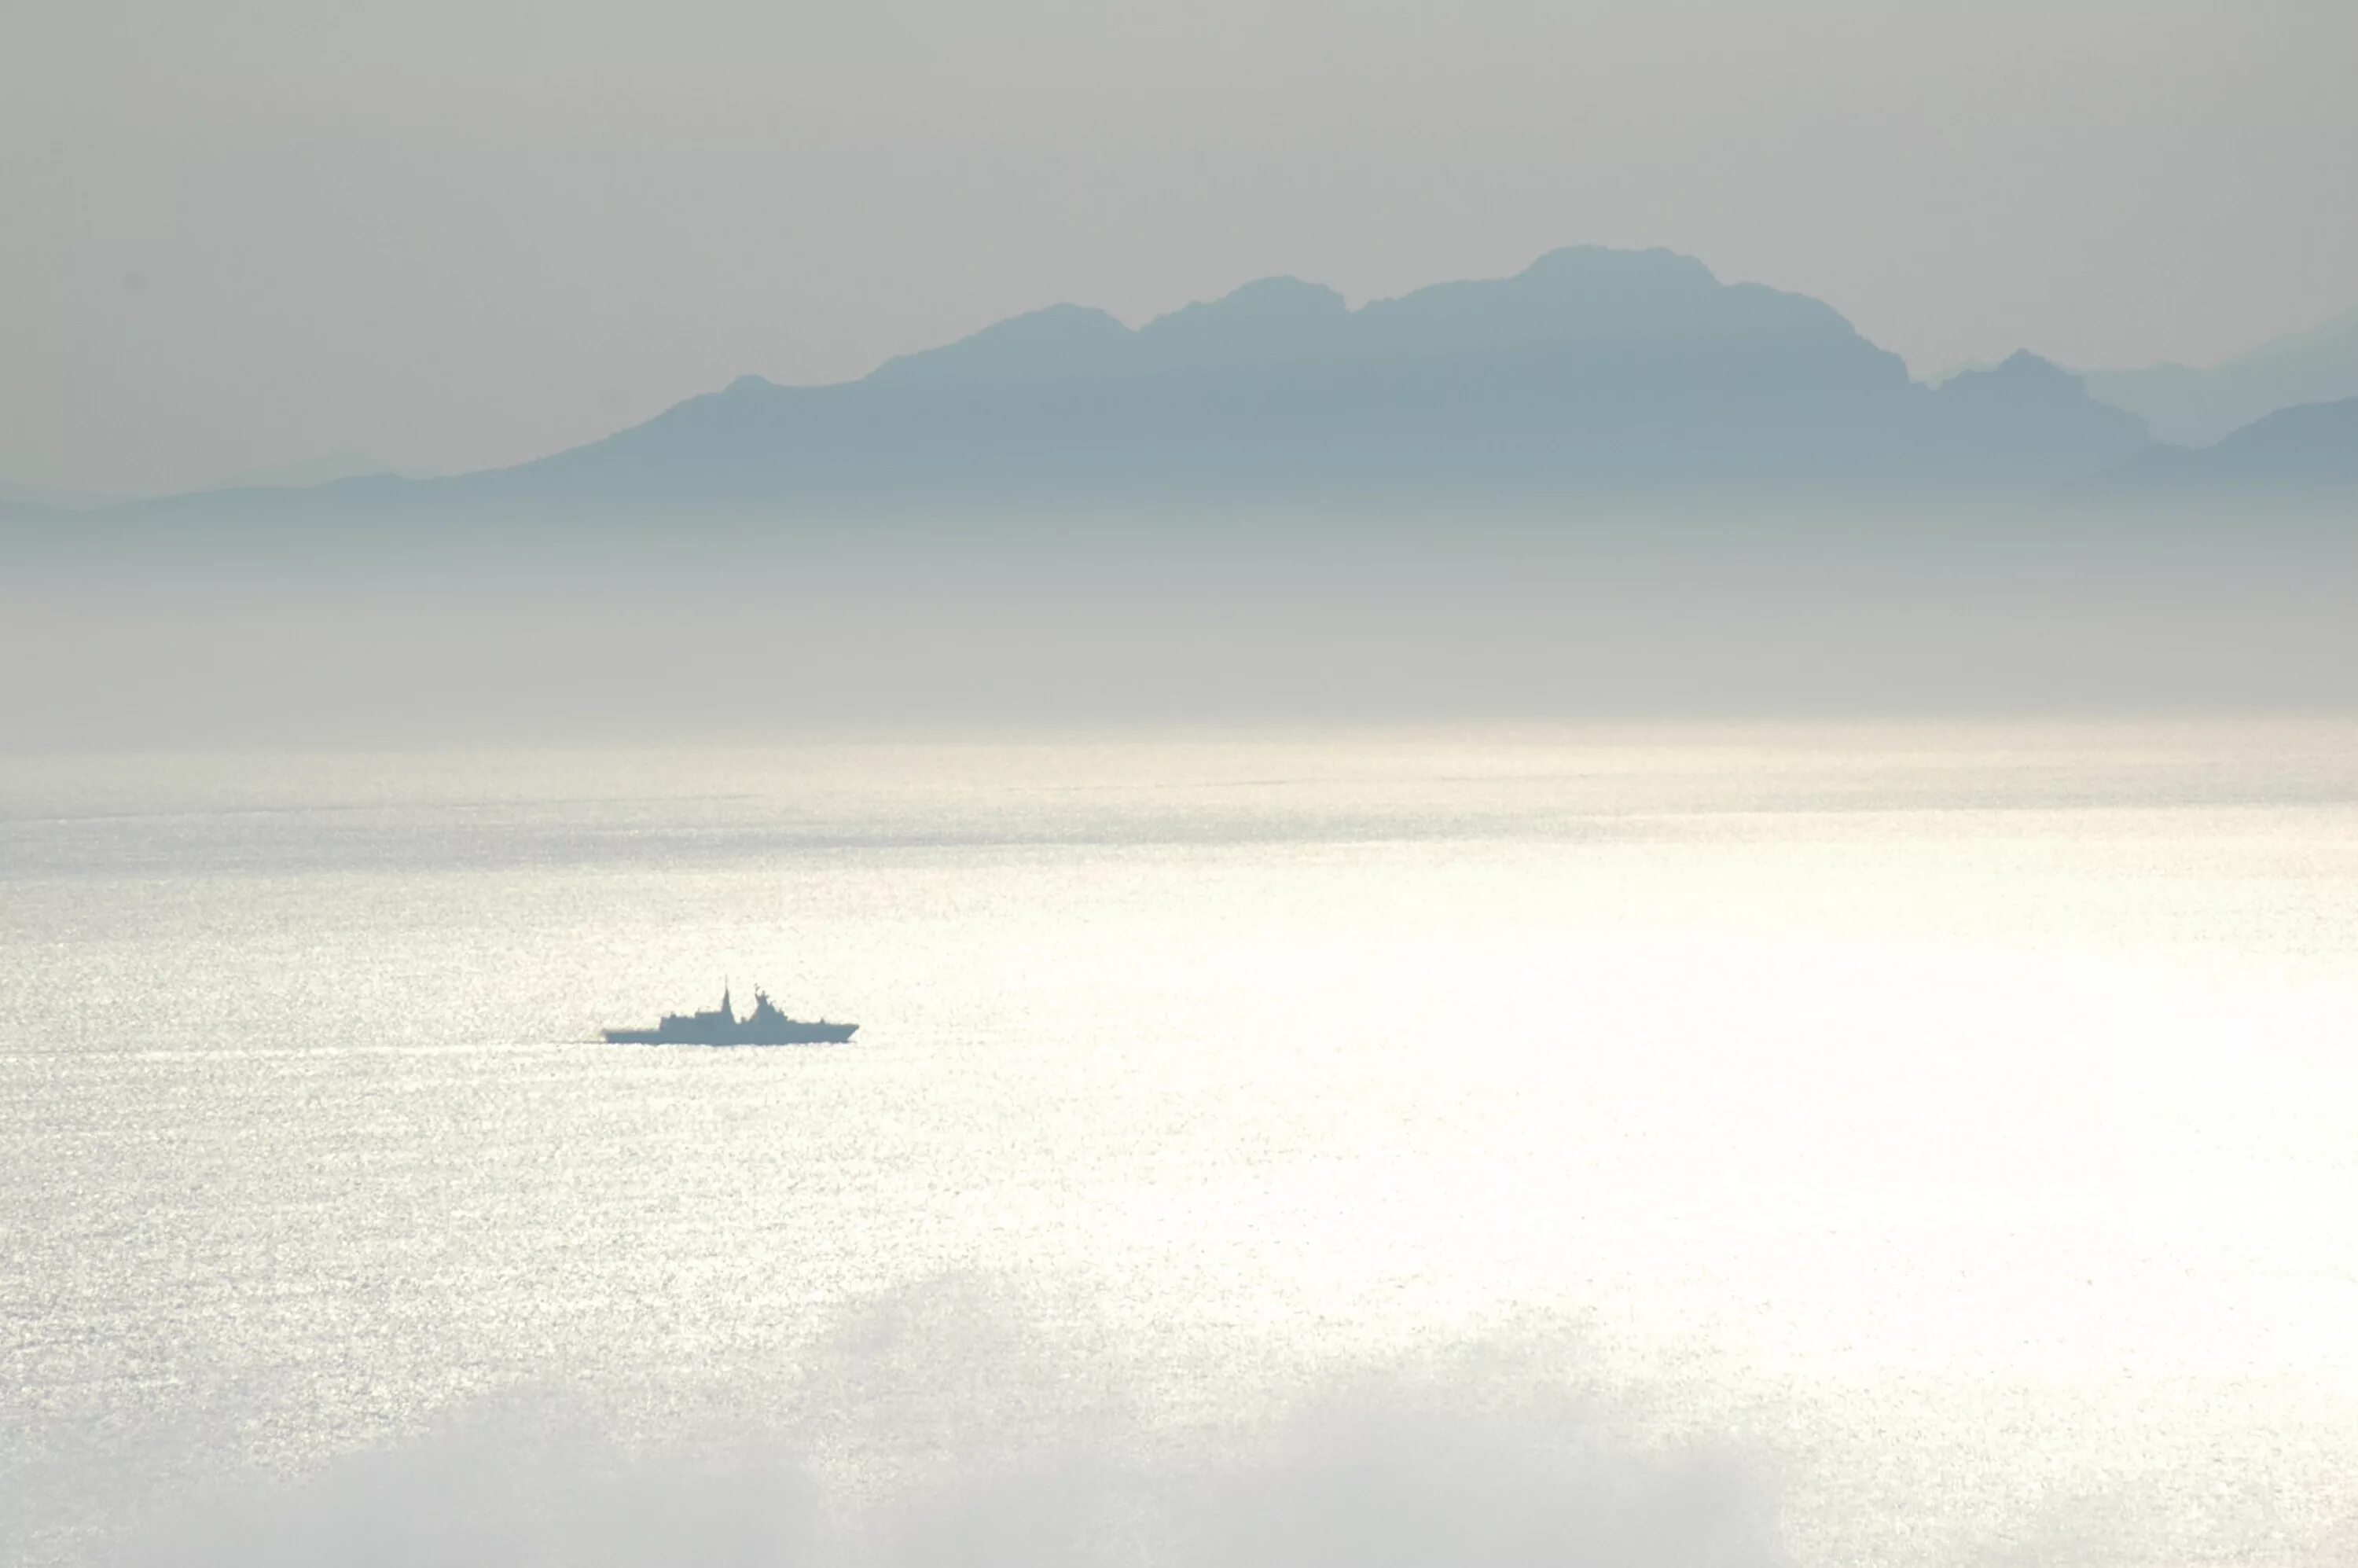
xmin=73 ymin=248 xmax=2188 ymax=516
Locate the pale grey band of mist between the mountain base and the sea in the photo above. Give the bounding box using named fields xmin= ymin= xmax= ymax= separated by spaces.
xmin=13 ymin=502 xmax=2358 ymax=750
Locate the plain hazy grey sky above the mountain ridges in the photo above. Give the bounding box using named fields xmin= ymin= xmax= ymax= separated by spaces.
xmin=0 ymin=0 xmax=2358 ymax=490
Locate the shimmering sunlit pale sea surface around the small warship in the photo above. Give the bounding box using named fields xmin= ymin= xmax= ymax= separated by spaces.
xmin=0 ymin=722 xmax=2358 ymax=1568
